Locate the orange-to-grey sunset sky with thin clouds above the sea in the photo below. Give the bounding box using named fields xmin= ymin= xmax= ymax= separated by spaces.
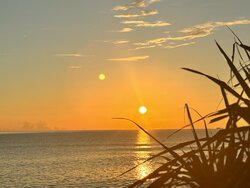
xmin=0 ymin=0 xmax=250 ymax=131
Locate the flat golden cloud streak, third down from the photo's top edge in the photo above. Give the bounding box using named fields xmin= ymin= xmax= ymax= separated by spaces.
xmin=121 ymin=20 xmax=171 ymax=27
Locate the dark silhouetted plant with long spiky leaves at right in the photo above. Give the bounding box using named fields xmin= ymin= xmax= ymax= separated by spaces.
xmin=118 ymin=28 xmax=250 ymax=188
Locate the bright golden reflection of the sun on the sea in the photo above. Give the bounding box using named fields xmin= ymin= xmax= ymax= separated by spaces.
xmin=135 ymin=131 xmax=152 ymax=179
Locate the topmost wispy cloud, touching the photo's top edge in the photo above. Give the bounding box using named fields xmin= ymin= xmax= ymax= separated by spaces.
xmin=113 ymin=0 xmax=158 ymax=11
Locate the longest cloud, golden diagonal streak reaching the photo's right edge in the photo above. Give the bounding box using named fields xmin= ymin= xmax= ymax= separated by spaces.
xmin=134 ymin=20 xmax=250 ymax=49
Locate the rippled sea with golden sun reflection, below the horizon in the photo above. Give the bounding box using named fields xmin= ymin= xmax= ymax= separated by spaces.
xmin=0 ymin=130 xmax=213 ymax=188
